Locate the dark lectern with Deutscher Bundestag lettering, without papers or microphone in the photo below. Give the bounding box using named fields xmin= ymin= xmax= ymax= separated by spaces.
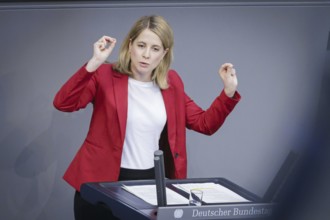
xmin=81 ymin=178 xmax=273 ymax=220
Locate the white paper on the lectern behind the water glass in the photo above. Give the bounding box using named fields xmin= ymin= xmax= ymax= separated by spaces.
xmin=173 ymin=182 xmax=250 ymax=203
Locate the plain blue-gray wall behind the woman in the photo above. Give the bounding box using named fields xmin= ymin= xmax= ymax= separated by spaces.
xmin=0 ymin=1 xmax=330 ymax=220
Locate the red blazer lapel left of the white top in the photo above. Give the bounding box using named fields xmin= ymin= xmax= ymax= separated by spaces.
xmin=113 ymin=73 xmax=128 ymax=141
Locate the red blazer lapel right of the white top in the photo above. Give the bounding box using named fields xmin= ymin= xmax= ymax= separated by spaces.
xmin=162 ymin=87 xmax=176 ymax=152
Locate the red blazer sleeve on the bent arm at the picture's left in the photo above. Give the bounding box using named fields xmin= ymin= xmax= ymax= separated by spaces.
xmin=53 ymin=65 xmax=97 ymax=112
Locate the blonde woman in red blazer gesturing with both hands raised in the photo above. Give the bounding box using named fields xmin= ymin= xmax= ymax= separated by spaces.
xmin=54 ymin=16 xmax=240 ymax=219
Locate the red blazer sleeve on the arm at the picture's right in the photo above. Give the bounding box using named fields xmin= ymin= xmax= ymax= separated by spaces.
xmin=185 ymin=90 xmax=241 ymax=135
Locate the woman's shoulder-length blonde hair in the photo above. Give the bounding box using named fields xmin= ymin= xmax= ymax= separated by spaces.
xmin=114 ymin=15 xmax=174 ymax=89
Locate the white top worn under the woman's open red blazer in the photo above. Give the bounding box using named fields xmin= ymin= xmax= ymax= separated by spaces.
xmin=121 ymin=78 xmax=166 ymax=169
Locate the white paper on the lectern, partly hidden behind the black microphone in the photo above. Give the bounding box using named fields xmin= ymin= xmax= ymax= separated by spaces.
xmin=122 ymin=185 xmax=189 ymax=205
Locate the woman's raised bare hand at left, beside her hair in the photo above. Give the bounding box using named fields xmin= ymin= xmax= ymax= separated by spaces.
xmin=86 ymin=36 xmax=116 ymax=72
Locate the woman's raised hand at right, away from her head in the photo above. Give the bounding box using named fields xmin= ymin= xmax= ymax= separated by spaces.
xmin=219 ymin=63 xmax=238 ymax=98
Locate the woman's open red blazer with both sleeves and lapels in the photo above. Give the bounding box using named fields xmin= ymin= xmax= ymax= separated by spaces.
xmin=54 ymin=64 xmax=240 ymax=191
